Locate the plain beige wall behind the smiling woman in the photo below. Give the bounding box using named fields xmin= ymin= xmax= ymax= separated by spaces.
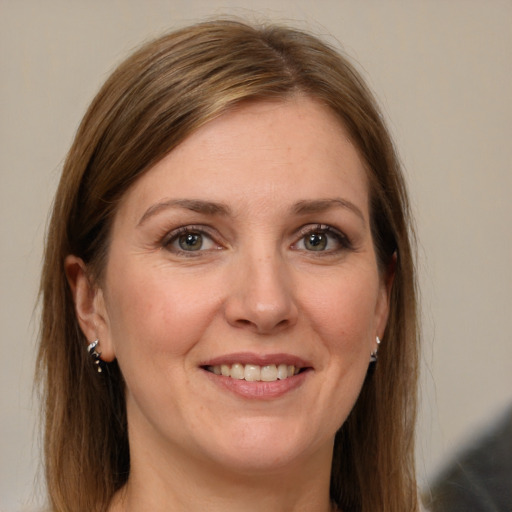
xmin=0 ymin=0 xmax=512 ymax=511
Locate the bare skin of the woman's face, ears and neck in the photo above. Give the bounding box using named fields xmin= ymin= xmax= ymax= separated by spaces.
xmin=66 ymin=97 xmax=392 ymax=512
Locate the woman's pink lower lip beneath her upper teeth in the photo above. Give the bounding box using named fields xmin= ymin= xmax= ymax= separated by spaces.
xmin=203 ymin=370 xmax=310 ymax=400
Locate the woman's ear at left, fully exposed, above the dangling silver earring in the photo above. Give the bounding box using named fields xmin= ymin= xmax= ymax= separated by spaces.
xmin=64 ymin=255 xmax=115 ymax=362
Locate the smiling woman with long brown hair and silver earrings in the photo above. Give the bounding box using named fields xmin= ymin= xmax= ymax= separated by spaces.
xmin=39 ymin=21 xmax=418 ymax=512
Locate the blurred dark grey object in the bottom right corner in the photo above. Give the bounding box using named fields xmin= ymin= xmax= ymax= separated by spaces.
xmin=426 ymin=407 xmax=512 ymax=512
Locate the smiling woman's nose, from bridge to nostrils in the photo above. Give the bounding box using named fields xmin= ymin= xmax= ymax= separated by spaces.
xmin=225 ymin=249 xmax=298 ymax=334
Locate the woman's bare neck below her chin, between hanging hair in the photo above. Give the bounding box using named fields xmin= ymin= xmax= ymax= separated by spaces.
xmin=109 ymin=432 xmax=335 ymax=512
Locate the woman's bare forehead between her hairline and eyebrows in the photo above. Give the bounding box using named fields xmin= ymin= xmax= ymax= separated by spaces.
xmin=118 ymin=96 xmax=368 ymax=223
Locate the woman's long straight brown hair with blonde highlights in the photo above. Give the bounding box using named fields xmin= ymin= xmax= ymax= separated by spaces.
xmin=37 ymin=21 xmax=418 ymax=512
